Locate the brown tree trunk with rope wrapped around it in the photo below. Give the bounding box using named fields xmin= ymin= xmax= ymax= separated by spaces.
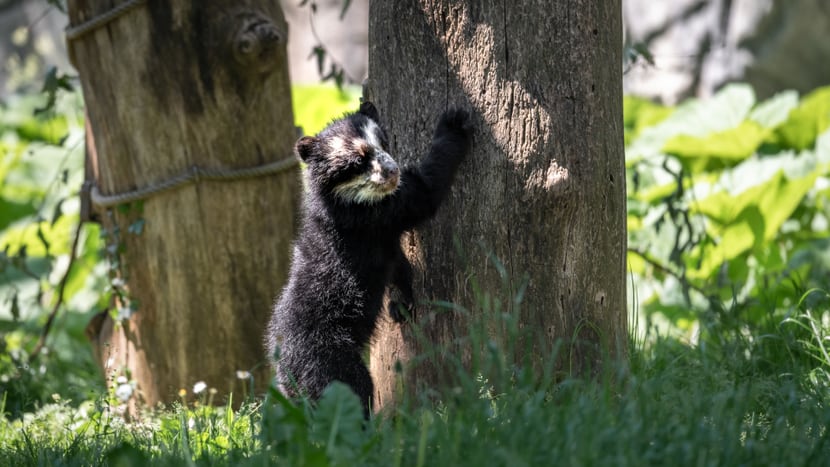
xmin=67 ymin=0 xmax=300 ymax=405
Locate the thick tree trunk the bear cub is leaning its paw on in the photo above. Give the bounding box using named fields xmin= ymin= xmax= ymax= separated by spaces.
xmin=366 ymin=0 xmax=626 ymax=405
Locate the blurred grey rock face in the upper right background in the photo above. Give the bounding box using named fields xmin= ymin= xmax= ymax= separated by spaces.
xmin=623 ymin=0 xmax=830 ymax=103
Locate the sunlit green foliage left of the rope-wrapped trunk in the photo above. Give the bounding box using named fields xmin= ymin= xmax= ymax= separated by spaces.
xmin=0 ymin=91 xmax=103 ymax=416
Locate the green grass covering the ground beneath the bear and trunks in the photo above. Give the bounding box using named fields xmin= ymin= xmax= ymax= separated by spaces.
xmin=0 ymin=292 xmax=830 ymax=466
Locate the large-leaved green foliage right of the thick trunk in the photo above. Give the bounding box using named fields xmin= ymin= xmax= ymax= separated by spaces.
xmin=626 ymin=85 xmax=830 ymax=337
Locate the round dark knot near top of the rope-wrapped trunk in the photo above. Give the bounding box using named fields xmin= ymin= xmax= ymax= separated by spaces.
xmin=231 ymin=11 xmax=286 ymax=75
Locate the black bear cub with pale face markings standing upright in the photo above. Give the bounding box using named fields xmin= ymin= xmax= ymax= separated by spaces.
xmin=266 ymin=102 xmax=472 ymax=418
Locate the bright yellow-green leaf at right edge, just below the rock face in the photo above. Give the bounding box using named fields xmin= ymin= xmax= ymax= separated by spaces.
xmin=773 ymin=86 xmax=830 ymax=150
